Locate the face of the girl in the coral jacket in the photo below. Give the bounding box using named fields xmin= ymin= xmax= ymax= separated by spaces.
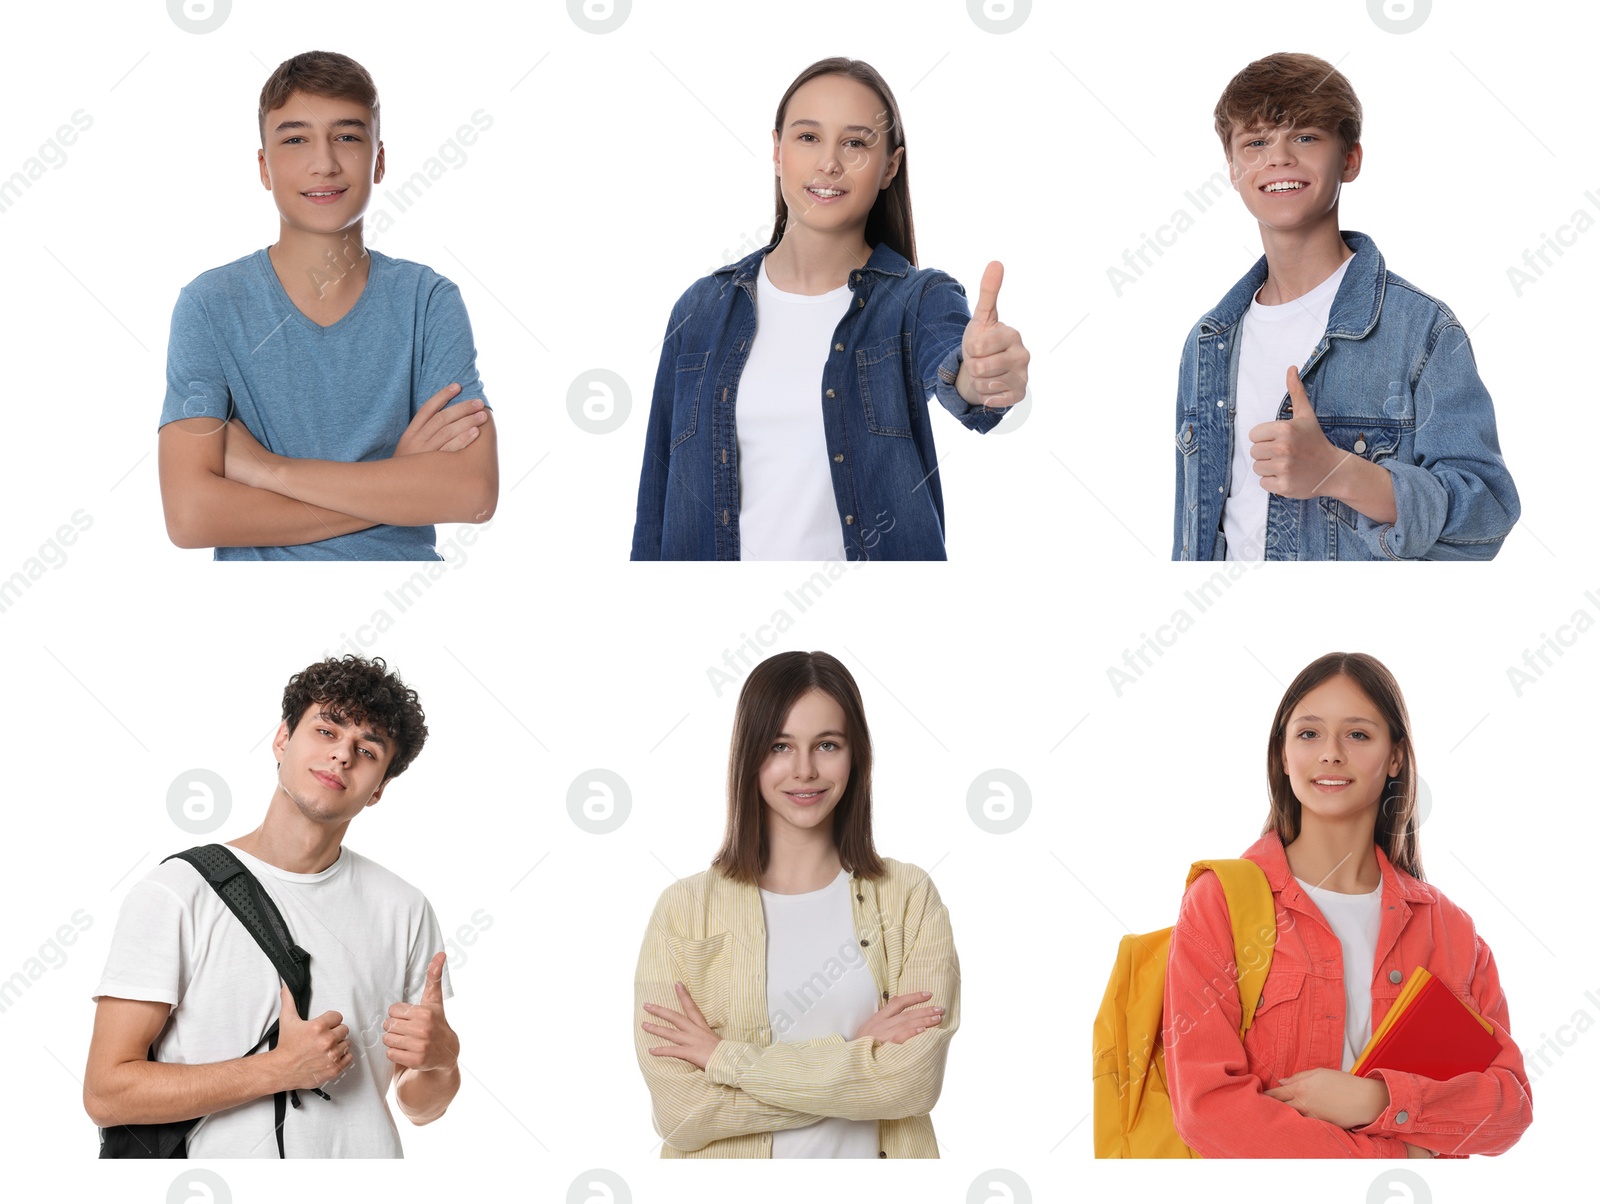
xmin=1283 ymin=674 xmax=1405 ymax=825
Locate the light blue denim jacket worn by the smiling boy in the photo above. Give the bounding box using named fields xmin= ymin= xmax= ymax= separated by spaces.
xmin=1173 ymin=231 xmax=1522 ymax=560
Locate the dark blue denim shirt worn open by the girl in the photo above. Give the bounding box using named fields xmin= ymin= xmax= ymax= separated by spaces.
xmin=632 ymin=243 xmax=1005 ymax=560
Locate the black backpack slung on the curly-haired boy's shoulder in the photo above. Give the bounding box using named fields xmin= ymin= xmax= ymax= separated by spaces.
xmin=99 ymin=844 xmax=330 ymax=1158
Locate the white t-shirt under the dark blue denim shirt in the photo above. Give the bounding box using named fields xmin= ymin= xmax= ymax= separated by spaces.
xmin=734 ymin=258 xmax=851 ymax=560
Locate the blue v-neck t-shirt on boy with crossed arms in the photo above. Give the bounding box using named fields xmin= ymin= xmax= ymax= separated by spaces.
xmin=160 ymin=250 xmax=488 ymax=560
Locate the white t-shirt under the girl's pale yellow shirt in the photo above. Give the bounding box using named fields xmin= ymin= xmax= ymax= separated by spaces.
xmin=762 ymin=869 xmax=878 ymax=1158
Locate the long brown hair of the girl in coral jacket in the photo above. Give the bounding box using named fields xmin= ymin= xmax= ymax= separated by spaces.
xmin=1261 ymin=652 xmax=1426 ymax=881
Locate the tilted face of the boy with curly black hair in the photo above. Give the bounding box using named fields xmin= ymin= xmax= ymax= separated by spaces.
xmin=272 ymin=703 xmax=394 ymax=823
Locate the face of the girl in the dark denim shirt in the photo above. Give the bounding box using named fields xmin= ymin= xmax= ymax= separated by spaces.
xmin=773 ymin=75 xmax=904 ymax=239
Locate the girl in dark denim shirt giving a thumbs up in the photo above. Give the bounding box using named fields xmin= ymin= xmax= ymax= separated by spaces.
xmin=632 ymin=58 xmax=1029 ymax=560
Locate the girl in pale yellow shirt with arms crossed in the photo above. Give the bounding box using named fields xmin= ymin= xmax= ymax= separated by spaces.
xmin=634 ymin=652 xmax=960 ymax=1158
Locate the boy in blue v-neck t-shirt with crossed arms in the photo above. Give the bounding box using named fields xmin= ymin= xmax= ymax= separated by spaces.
xmin=160 ymin=51 xmax=499 ymax=560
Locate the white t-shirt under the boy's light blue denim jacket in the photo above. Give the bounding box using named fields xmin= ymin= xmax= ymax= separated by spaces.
xmin=1222 ymin=256 xmax=1354 ymax=560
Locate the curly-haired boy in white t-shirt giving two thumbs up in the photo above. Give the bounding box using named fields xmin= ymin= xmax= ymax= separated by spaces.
xmin=83 ymin=656 xmax=461 ymax=1158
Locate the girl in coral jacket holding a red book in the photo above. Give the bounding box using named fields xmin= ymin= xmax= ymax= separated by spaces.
xmin=1165 ymin=652 xmax=1533 ymax=1158
